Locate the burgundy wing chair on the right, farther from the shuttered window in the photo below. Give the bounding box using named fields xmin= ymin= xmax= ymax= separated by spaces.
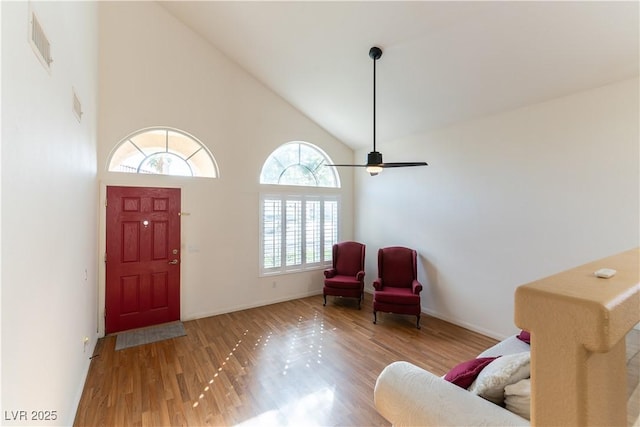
xmin=373 ymin=246 xmax=422 ymax=329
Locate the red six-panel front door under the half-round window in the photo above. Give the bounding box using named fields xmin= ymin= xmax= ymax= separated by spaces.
xmin=105 ymin=187 xmax=180 ymax=333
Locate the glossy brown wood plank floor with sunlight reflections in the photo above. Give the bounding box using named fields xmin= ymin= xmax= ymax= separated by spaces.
xmin=75 ymin=295 xmax=640 ymax=426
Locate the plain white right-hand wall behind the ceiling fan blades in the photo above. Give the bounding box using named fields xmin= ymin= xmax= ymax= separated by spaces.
xmin=355 ymin=79 xmax=640 ymax=338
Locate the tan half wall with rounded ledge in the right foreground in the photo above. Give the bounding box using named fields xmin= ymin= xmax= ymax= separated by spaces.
xmin=515 ymin=248 xmax=640 ymax=427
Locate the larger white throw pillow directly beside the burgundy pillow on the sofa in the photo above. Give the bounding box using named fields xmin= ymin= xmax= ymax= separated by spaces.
xmin=468 ymin=351 xmax=531 ymax=405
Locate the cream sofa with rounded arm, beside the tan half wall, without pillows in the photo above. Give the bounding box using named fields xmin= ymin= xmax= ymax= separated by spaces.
xmin=374 ymin=335 xmax=530 ymax=426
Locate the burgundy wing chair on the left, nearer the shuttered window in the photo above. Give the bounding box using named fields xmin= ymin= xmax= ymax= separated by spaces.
xmin=322 ymin=242 xmax=365 ymax=310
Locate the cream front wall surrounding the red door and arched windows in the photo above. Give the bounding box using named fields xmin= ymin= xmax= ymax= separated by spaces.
xmin=98 ymin=2 xmax=353 ymax=334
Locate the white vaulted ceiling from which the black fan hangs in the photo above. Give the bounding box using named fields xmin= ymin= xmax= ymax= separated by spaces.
xmin=160 ymin=1 xmax=640 ymax=148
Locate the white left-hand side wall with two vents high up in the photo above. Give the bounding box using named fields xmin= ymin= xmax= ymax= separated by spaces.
xmin=0 ymin=2 xmax=98 ymax=425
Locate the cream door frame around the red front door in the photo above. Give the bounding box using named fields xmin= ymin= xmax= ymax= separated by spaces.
xmin=96 ymin=181 xmax=188 ymax=337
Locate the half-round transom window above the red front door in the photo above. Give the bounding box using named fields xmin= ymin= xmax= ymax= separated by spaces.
xmin=109 ymin=128 xmax=218 ymax=178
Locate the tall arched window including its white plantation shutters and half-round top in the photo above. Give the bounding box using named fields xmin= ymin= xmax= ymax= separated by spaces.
xmin=260 ymin=142 xmax=340 ymax=275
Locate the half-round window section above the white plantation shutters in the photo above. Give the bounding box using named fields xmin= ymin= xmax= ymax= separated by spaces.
xmin=260 ymin=141 xmax=340 ymax=188
